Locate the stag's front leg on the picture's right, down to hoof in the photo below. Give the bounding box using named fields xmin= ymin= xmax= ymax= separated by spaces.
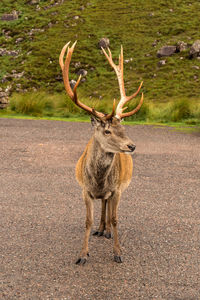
xmin=110 ymin=192 xmax=122 ymax=263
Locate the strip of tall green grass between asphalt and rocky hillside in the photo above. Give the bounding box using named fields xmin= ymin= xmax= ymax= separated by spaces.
xmin=2 ymin=92 xmax=200 ymax=125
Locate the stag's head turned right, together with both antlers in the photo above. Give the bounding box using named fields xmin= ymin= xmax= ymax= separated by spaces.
xmin=59 ymin=42 xmax=143 ymax=153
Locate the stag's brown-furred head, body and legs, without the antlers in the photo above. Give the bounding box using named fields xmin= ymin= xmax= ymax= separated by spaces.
xmin=76 ymin=120 xmax=134 ymax=264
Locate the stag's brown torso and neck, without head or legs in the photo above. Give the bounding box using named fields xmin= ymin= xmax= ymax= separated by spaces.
xmin=76 ymin=138 xmax=133 ymax=199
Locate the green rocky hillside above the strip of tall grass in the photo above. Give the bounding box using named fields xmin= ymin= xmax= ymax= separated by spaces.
xmin=0 ymin=0 xmax=200 ymax=108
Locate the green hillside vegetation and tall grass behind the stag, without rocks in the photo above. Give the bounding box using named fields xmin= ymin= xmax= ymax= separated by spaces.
xmin=0 ymin=0 xmax=200 ymax=123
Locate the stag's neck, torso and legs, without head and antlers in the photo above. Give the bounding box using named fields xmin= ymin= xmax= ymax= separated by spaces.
xmin=76 ymin=137 xmax=133 ymax=264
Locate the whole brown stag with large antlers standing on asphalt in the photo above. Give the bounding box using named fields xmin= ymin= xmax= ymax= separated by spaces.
xmin=59 ymin=42 xmax=143 ymax=265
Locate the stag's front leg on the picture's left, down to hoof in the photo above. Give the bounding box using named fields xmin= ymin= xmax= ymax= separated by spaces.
xmin=76 ymin=191 xmax=93 ymax=265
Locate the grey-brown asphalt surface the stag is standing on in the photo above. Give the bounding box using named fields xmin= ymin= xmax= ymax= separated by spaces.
xmin=0 ymin=119 xmax=200 ymax=300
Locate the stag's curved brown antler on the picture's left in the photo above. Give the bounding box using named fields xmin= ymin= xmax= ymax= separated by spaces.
xmin=59 ymin=41 xmax=115 ymax=121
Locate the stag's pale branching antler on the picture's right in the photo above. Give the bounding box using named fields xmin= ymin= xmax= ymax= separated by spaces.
xmin=101 ymin=46 xmax=143 ymax=119
